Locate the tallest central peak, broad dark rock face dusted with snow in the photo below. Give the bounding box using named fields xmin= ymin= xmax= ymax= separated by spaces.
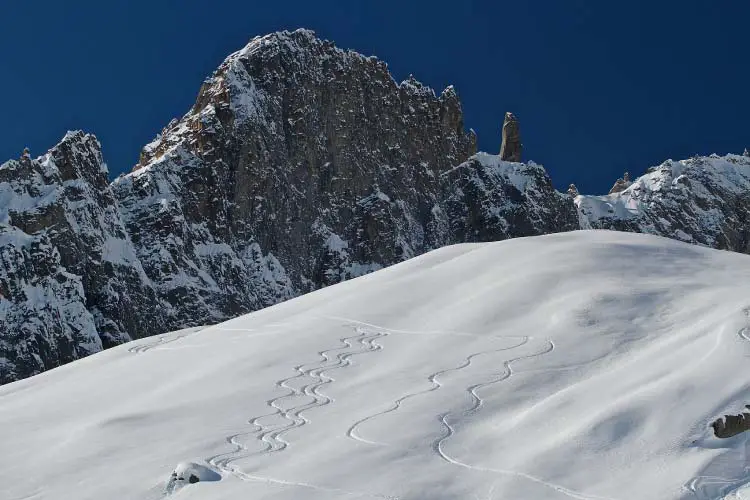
xmin=113 ymin=30 xmax=476 ymax=324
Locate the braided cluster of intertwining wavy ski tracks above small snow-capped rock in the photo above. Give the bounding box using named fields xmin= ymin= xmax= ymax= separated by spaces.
xmin=206 ymin=327 xmax=396 ymax=500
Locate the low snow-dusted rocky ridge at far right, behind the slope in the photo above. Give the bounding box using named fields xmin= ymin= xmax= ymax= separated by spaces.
xmin=576 ymin=154 xmax=750 ymax=253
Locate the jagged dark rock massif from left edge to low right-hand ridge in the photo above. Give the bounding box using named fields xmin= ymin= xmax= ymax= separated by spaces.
xmin=0 ymin=30 xmax=577 ymax=383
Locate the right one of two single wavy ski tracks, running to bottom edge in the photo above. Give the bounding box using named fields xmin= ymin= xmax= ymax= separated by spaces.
xmin=432 ymin=339 xmax=612 ymax=500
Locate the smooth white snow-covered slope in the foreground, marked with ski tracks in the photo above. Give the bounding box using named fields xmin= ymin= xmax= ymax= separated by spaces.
xmin=0 ymin=231 xmax=750 ymax=500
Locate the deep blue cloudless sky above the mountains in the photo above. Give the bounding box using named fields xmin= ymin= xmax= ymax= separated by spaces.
xmin=0 ymin=0 xmax=750 ymax=193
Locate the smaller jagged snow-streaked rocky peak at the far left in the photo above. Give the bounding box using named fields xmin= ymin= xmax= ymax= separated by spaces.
xmin=0 ymin=132 xmax=164 ymax=381
